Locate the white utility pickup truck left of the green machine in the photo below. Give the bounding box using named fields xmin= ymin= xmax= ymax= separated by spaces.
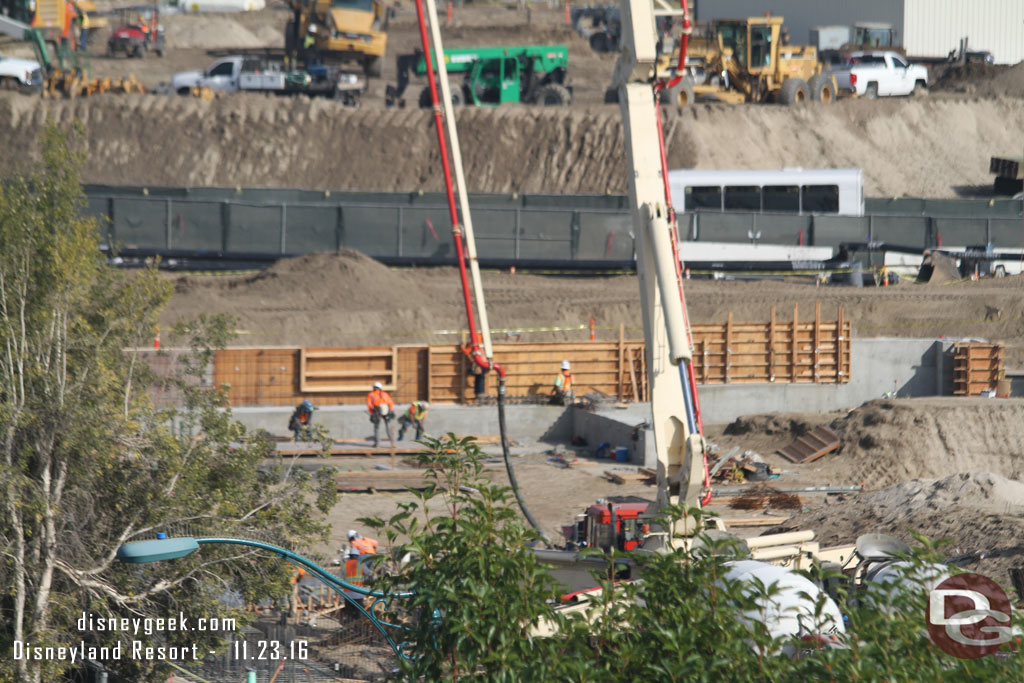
xmin=171 ymin=54 xmax=366 ymax=104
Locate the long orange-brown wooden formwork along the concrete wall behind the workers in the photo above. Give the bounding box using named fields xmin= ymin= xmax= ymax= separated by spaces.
xmin=195 ymin=305 xmax=852 ymax=405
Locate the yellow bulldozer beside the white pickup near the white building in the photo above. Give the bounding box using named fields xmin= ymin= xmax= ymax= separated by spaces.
xmin=658 ymin=15 xmax=837 ymax=105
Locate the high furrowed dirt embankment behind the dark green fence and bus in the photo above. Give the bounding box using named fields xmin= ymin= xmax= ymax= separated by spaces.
xmin=6 ymin=93 xmax=1024 ymax=197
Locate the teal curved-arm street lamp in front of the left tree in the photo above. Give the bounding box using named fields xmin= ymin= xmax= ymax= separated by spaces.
xmin=117 ymin=533 xmax=412 ymax=657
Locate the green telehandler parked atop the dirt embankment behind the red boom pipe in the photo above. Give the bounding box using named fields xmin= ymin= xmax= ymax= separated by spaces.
xmin=386 ymin=45 xmax=572 ymax=108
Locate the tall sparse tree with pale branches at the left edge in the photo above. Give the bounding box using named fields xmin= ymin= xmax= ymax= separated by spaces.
xmin=0 ymin=122 xmax=332 ymax=682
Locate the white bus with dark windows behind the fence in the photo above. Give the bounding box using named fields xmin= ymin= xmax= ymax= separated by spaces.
xmin=669 ymin=168 xmax=864 ymax=216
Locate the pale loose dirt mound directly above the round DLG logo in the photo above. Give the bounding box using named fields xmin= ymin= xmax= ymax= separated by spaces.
xmin=790 ymin=472 xmax=1024 ymax=580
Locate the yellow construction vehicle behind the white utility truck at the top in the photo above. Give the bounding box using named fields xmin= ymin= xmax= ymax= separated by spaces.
xmin=285 ymin=0 xmax=389 ymax=77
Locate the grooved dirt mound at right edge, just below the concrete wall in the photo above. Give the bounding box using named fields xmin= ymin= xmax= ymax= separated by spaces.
xmin=829 ymin=398 xmax=1024 ymax=488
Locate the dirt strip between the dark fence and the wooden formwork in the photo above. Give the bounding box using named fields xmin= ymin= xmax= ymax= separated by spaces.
xmin=155 ymin=251 xmax=1024 ymax=366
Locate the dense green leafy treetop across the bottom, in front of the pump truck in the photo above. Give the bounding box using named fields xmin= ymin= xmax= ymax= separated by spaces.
xmin=361 ymin=434 xmax=1024 ymax=683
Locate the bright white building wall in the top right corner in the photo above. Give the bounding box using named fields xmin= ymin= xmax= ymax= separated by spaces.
xmin=903 ymin=0 xmax=1024 ymax=63
